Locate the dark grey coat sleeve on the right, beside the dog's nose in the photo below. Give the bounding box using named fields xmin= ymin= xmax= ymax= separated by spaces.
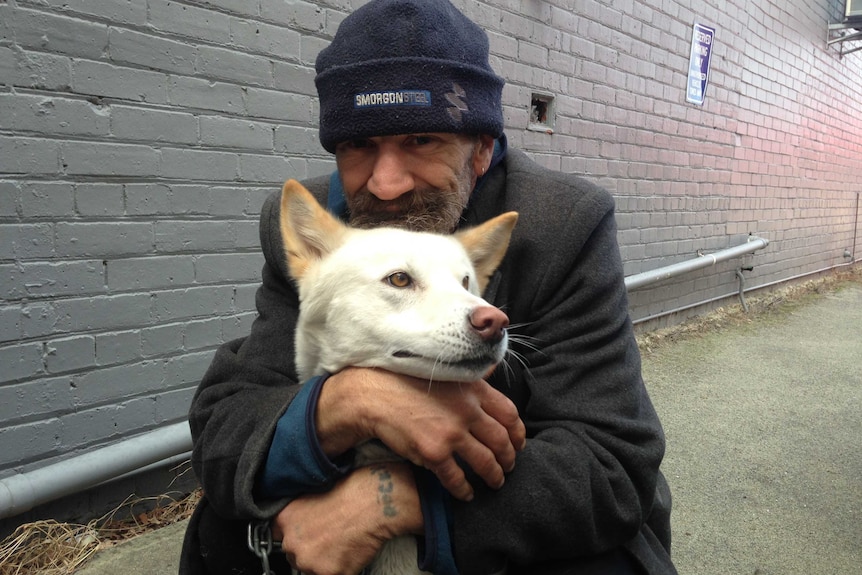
xmin=453 ymin=175 xmax=664 ymax=575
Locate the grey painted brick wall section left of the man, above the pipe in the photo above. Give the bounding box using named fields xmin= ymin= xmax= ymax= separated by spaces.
xmin=0 ymin=0 xmax=338 ymax=486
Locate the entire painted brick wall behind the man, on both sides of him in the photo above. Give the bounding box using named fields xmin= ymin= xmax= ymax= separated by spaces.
xmin=0 ymin=0 xmax=862 ymax=524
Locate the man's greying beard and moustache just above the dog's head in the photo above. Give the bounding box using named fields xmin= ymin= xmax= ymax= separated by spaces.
xmin=347 ymin=155 xmax=473 ymax=234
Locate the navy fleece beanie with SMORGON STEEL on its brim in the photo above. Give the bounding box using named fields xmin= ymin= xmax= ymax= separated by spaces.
xmin=314 ymin=0 xmax=503 ymax=152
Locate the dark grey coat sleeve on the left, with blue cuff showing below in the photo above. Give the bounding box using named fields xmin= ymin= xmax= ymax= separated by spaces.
xmin=189 ymin=190 xmax=308 ymax=519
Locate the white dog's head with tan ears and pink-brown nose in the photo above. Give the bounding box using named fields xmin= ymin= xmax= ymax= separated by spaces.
xmin=280 ymin=180 xmax=518 ymax=388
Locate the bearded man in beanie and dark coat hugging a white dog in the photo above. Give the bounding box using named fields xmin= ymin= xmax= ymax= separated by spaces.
xmin=180 ymin=0 xmax=675 ymax=575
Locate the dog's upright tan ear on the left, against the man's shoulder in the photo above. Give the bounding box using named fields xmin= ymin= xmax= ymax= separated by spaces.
xmin=279 ymin=180 xmax=348 ymax=279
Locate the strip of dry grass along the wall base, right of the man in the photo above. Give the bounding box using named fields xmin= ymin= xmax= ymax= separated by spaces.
xmin=637 ymin=265 xmax=862 ymax=355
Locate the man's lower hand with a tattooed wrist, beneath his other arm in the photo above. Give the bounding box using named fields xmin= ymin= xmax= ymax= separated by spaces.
xmin=272 ymin=463 xmax=423 ymax=575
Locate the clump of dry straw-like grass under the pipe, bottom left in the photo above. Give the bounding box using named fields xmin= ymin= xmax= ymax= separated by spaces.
xmin=0 ymin=490 xmax=201 ymax=575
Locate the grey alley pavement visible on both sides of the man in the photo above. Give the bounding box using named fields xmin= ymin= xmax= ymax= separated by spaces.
xmin=76 ymin=283 xmax=862 ymax=575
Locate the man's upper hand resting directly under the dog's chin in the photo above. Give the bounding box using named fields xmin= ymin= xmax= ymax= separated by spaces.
xmin=316 ymin=368 xmax=526 ymax=501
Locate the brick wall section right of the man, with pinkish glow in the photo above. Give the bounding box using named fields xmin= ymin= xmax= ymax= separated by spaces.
xmin=480 ymin=0 xmax=862 ymax=324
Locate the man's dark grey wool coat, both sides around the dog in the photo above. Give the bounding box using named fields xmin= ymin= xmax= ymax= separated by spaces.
xmin=190 ymin=150 xmax=676 ymax=575
